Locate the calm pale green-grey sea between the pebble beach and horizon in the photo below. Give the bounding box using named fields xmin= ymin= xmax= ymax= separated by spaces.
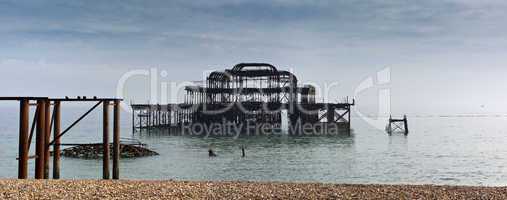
xmin=0 ymin=106 xmax=507 ymax=186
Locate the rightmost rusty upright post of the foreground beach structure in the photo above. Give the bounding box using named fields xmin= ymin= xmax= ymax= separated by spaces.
xmin=113 ymin=100 xmax=120 ymax=179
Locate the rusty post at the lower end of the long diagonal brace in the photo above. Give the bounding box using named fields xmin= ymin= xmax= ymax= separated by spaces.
xmin=53 ymin=101 xmax=62 ymax=179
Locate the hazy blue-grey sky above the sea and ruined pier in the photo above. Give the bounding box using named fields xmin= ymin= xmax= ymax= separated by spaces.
xmin=0 ymin=0 xmax=507 ymax=113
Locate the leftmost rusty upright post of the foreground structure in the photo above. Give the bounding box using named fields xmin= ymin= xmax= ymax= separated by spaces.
xmin=18 ymin=99 xmax=30 ymax=179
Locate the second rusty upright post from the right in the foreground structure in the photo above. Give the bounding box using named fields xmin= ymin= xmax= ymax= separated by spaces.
xmin=102 ymin=100 xmax=109 ymax=179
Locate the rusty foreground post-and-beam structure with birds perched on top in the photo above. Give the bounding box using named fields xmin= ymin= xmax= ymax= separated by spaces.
xmin=0 ymin=97 xmax=122 ymax=179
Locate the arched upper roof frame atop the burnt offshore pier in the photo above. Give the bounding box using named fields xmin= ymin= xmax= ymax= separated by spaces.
xmin=192 ymin=63 xmax=301 ymax=104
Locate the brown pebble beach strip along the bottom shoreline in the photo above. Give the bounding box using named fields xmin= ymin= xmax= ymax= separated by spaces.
xmin=0 ymin=179 xmax=507 ymax=199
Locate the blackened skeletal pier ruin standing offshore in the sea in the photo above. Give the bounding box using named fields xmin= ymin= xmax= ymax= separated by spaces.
xmin=131 ymin=63 xmax=355 ymax=134
